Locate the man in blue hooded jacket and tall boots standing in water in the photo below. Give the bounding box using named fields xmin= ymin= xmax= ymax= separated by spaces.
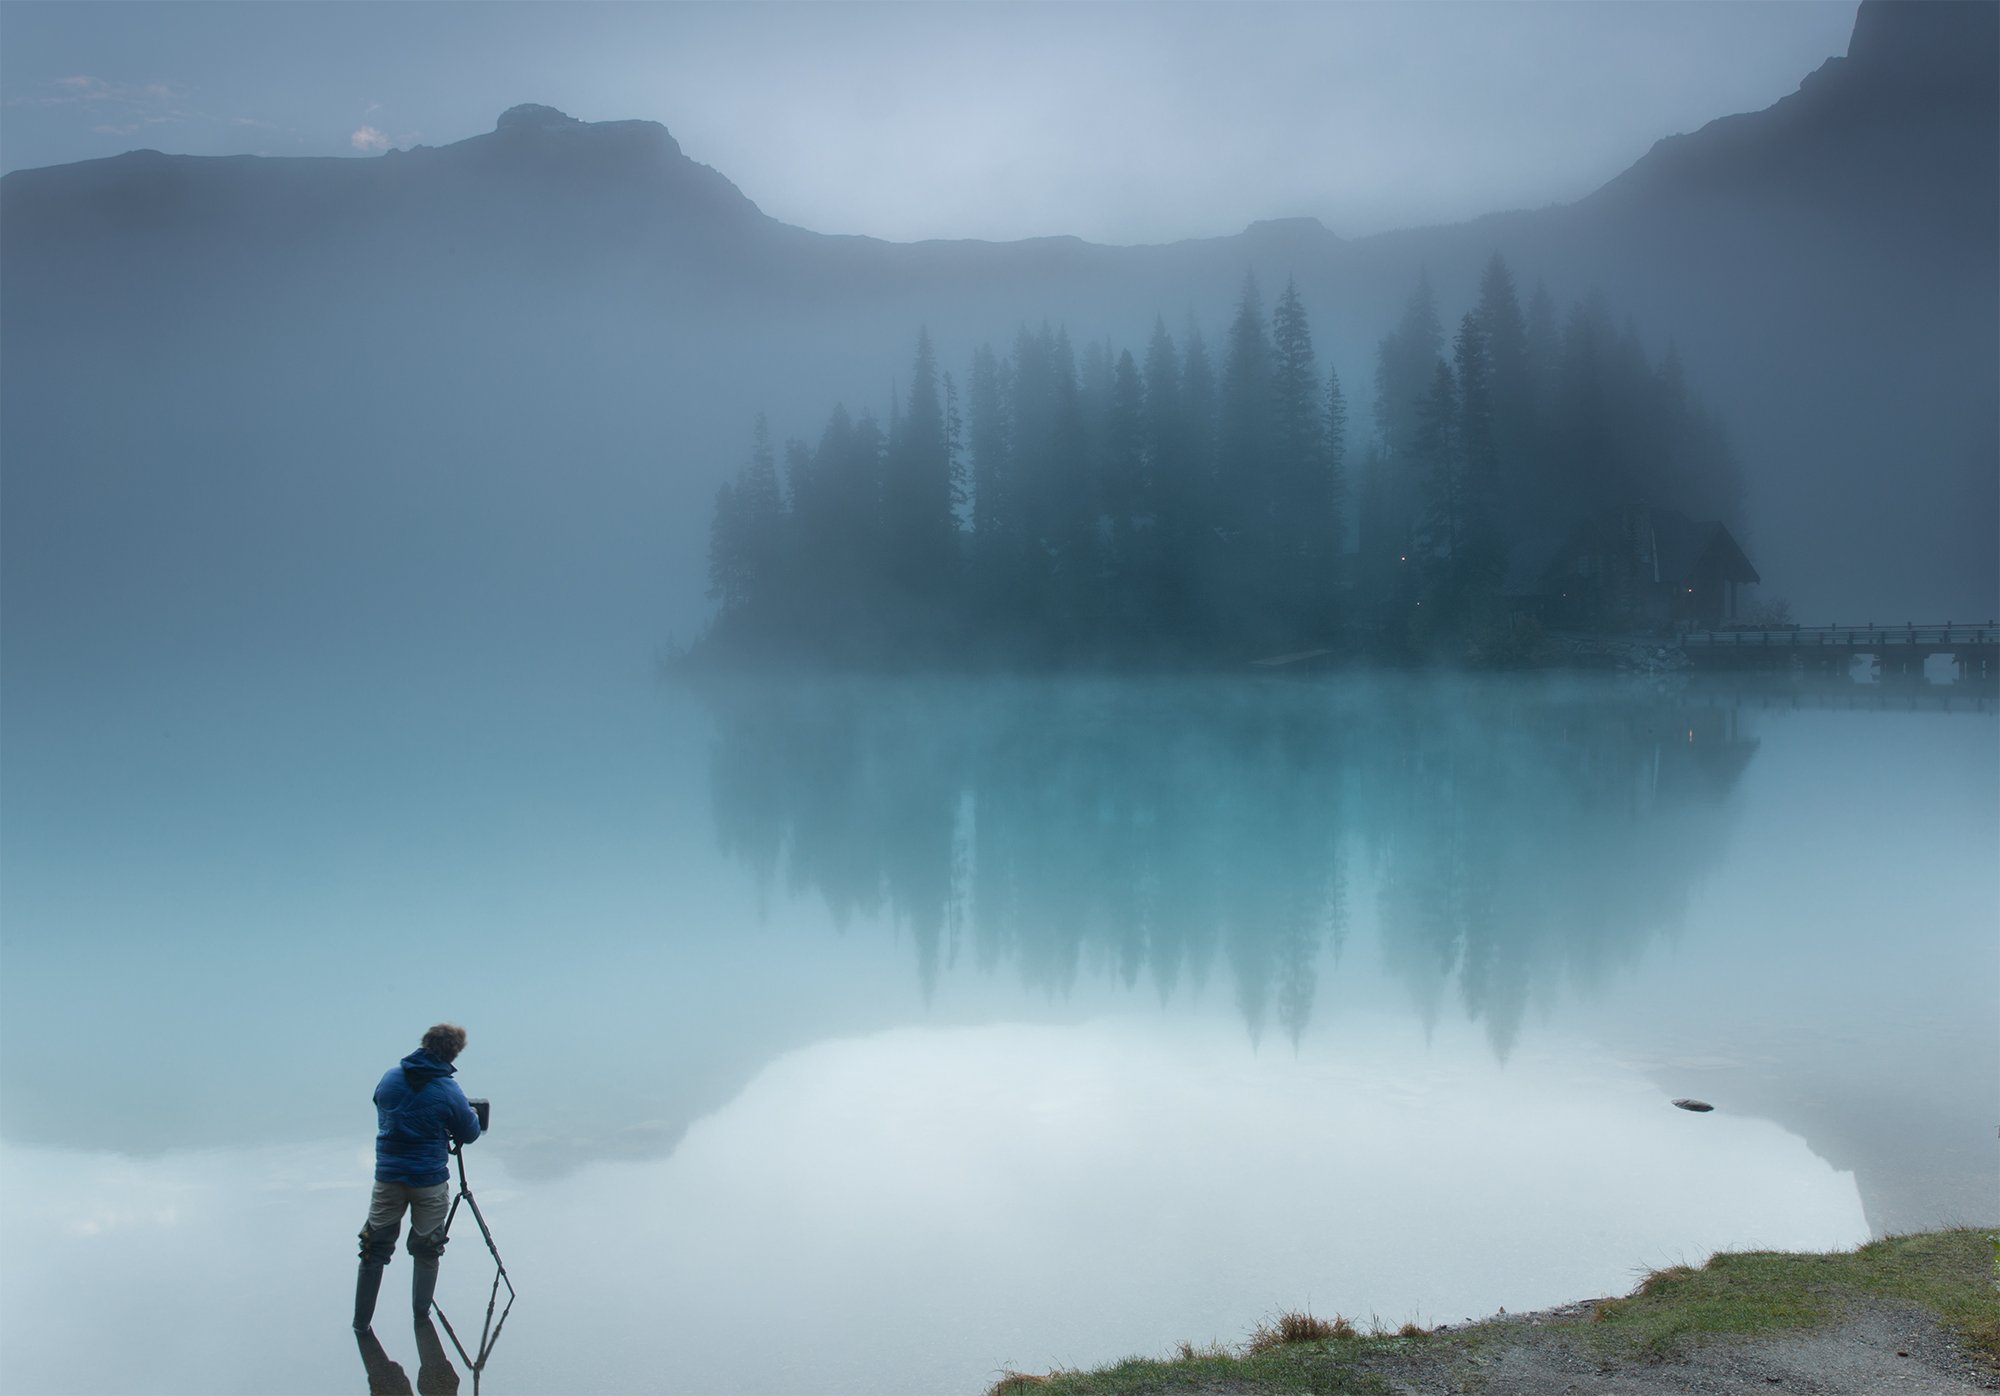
xmin=354 ymin=1022 xmax=480 ymax=1332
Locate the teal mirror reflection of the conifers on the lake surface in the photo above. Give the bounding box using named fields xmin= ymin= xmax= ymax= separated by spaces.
xmin=710 ymin=678 xmax=1756 ymax=1052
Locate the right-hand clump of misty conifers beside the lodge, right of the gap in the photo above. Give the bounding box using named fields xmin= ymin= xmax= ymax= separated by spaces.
xmin=1352 ymin=256 xmax=1742 ymax=650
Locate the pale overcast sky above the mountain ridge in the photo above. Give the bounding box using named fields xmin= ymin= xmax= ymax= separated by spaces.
xmin=0 ymin=0 xmax=1856 ymax=242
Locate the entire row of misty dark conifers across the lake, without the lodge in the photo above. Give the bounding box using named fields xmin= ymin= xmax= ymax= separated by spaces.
xmin=708 ymin=256 xmax=1740 ymax=664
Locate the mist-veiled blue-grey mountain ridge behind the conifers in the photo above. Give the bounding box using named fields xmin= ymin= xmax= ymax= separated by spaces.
xmin=0 ymin=0 xmax=2000 ymax=648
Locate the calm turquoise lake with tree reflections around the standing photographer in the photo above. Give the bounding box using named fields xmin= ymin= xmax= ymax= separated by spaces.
xmin=0 ymin=672 xmax=2000 ymax=1396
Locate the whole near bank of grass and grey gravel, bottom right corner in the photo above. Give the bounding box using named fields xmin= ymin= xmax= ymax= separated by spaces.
xmin=986 ymin=1226 xmax=2000 ymax=1396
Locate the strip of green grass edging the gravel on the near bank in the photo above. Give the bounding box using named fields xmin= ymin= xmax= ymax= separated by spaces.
xmin=988 ymin=1228 xmax=2000 ymax=1396
